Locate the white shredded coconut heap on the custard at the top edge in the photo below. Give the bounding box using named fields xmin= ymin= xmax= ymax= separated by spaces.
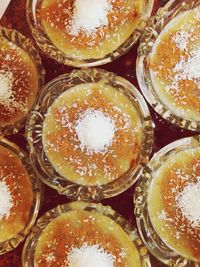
xmin=70 ymin=0 xmax=111 ymax=35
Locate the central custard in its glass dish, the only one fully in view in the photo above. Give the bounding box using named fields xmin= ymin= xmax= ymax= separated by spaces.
xmin=27 ymin=69 xmax=152 ymax=201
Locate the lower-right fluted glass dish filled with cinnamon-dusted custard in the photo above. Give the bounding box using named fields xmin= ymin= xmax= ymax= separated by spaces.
xmin=134 ymin=136 xmax=200 ymax=267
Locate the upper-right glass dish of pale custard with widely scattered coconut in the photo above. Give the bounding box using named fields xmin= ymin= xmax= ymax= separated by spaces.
xmin=137 ymin=1 xmax=200 ymax=130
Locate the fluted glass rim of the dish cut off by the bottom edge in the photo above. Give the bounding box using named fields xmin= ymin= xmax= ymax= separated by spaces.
xmin=22 ymin=201 xmax=151 ymax=267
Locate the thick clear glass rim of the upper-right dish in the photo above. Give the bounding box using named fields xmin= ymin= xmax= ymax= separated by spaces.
xmin=136 ymin=0 xmax=200 ymax=131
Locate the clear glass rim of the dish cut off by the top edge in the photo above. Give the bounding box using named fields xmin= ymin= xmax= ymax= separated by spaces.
xmin=26 ymin=0 xmax=154 ymax=67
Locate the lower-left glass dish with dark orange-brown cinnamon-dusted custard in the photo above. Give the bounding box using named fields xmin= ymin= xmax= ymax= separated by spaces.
xmin=0 ymin=137 xmax=41 ymax=255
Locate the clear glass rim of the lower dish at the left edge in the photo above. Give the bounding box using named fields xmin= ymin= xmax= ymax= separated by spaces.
xmin=0 ymin=137 xmax=41 ymax=255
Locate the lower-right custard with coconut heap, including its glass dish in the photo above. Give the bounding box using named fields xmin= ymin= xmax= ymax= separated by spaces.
xmin=136 ymin=136 xmax=200 ymax=266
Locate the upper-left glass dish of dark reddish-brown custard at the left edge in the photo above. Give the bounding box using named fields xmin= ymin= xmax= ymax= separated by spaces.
xmin=0 ymin=28 xmax=44 ymax=134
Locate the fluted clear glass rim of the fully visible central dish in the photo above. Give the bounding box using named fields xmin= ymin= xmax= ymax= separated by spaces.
xmin=26 ymin=69 xmax=153 ymax=200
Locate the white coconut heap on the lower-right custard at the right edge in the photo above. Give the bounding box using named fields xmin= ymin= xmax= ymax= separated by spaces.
xmin=177 ymin=177 xmax=200 ymax=227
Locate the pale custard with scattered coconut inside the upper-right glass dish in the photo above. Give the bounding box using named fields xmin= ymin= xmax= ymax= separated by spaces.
xmin=150 ymin=6 xmax=200 ymax=121
